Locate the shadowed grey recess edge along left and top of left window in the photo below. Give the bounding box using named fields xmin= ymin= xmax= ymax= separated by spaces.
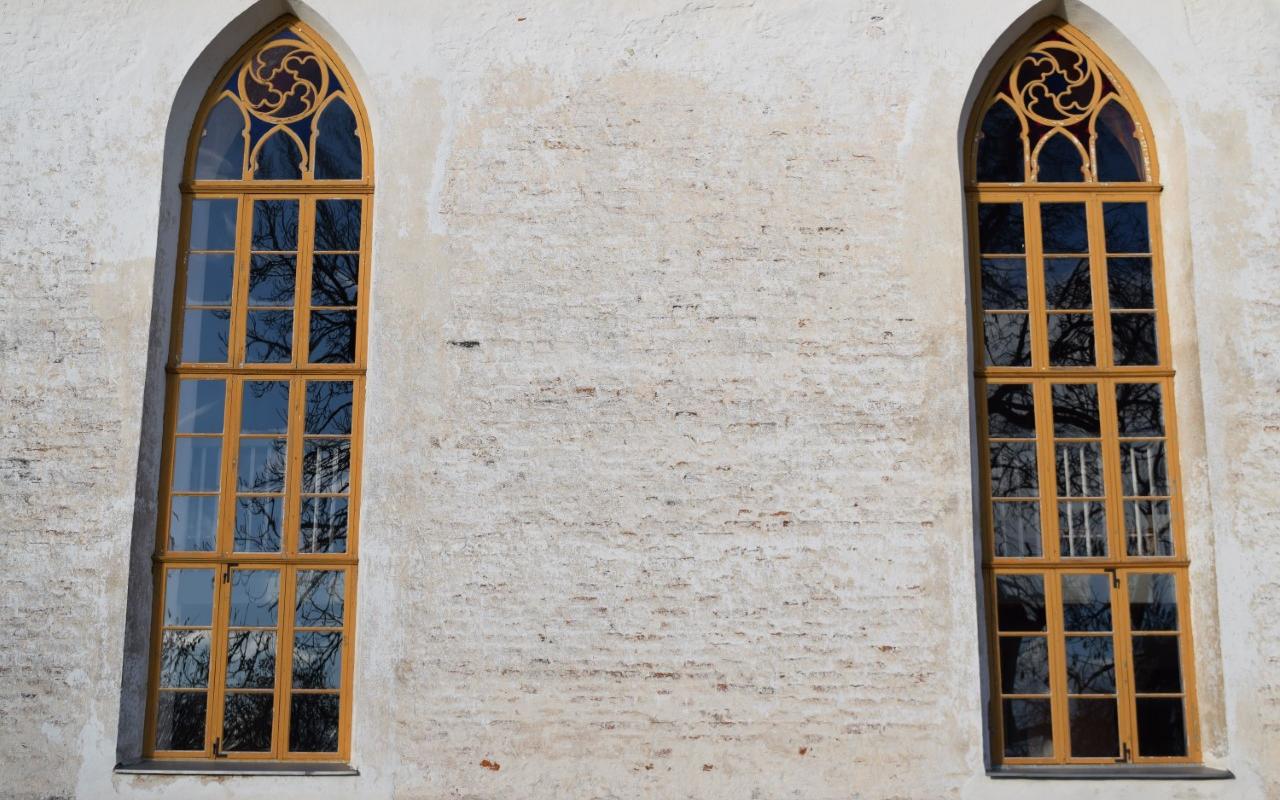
xmin=115 ymin=0 xmax=364 ymax=763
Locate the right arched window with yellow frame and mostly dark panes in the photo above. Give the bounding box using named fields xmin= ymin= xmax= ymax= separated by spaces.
xmin=966 ymin=19 xmax=1199 ymax=765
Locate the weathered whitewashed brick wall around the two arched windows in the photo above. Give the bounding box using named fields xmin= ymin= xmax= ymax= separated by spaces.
xmin=0 ymin=0 xmax=1280 ymax=800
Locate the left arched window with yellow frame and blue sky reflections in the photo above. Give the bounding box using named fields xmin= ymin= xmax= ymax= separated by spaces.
xmin=145 ymin=18 xmax=372 ymax=760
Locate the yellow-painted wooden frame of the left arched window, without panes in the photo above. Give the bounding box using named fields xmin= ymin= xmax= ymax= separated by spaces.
xmin=143 ymin=15 xmax=374 ymax=762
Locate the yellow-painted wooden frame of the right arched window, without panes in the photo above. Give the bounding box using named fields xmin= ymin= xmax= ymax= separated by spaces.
xmin=965 ymin=18 xmax=1202 ymax=767
